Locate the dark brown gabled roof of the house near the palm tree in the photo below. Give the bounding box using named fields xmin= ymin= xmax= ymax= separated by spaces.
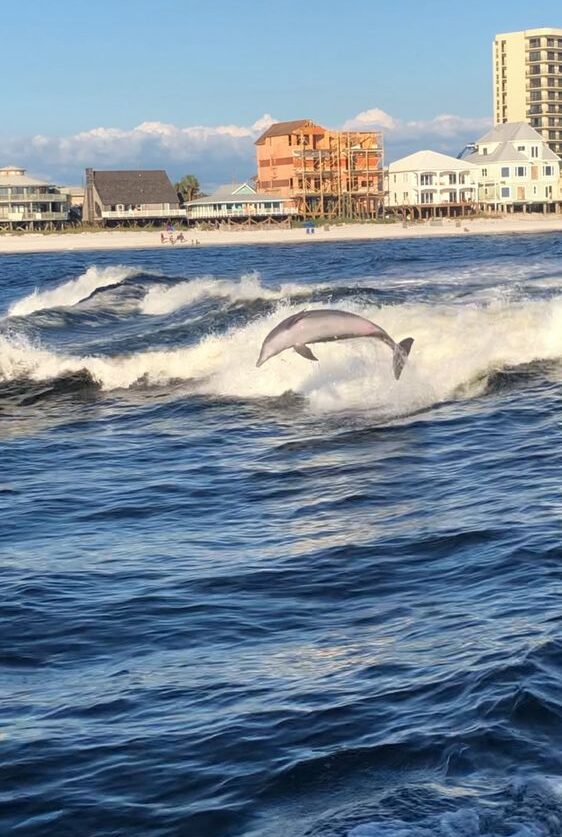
xmin=93 ymin=169 xmax=179 ymax=206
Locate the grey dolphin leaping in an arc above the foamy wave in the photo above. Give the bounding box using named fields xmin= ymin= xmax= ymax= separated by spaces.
xmin=256 ymin=308 xmax=414 ymax=380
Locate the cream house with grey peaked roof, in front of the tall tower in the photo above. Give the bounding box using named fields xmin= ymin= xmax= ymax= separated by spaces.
xmin=465 ymin=122 xmax=560 ymax=212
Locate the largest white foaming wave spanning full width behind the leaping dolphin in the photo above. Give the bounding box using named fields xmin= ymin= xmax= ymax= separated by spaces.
xmin=0 ymin=296 xmax=562 ymax=416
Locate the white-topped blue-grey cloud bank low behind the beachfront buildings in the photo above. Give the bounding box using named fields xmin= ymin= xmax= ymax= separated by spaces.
xmin=0 ymin=108 xmax=491 ymax=190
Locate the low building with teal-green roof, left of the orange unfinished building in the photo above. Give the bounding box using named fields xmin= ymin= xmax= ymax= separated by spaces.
xmin=185 ymin=183 xmax=297 ymax=225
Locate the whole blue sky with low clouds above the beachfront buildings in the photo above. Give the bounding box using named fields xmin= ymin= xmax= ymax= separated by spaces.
xmin=4 ymin=0 xmax=562 ymax=190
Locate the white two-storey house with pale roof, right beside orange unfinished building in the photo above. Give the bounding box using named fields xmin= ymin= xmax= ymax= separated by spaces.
xmin=385 ymin=151 xmax=479 ymax=220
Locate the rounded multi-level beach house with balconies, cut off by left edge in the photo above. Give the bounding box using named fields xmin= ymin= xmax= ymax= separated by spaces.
xmin=0 ymin=166 xmax=69 ymax=230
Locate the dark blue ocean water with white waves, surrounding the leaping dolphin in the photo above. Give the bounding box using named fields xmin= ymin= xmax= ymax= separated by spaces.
xmin=0 ymin=234 xmax=562 ymax=837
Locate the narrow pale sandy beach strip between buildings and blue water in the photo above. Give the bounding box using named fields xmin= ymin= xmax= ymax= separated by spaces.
xmin=0 ymin=215 xmax=562 ymax=256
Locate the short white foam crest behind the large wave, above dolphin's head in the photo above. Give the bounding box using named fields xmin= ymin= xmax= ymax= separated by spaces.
xmin=140 ymin=273 xmax=316 ymax=315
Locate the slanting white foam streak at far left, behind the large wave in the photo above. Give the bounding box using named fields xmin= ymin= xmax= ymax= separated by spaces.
xmin=6 ymin=265 xmax=140 ymax=317
